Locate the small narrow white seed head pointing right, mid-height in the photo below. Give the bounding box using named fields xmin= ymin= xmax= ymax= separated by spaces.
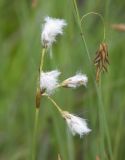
xmin=62 ymin=73 xmax=88 ymax=88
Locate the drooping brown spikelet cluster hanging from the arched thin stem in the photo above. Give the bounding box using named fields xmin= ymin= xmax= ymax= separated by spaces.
xmin=94 ymin=43 xmax=109 ymax=82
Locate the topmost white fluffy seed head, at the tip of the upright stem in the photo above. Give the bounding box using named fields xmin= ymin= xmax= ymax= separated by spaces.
xmin=41 ymin=17 xmax=67 ymax=48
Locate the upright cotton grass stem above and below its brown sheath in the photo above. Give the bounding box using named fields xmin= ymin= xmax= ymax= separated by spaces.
xmin=31 ymin=48 xmax=46 ymax=160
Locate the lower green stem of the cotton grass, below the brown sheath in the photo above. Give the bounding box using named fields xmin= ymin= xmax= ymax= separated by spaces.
xmin=32 ymin=108 xmax=39 ymax=160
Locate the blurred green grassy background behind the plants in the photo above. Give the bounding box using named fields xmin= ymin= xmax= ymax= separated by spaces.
xmin=0 ymin=0 xmax=125 ymax=160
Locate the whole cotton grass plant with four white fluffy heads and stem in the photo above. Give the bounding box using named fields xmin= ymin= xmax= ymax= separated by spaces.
xmin=32 ymin=17 xmax=91 ymax=160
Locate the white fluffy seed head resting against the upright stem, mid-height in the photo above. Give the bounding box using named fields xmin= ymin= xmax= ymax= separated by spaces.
xmin=40 ymin=70 xmax=61 ymax=95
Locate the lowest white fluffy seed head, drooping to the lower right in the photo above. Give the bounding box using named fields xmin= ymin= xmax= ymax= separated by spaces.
xmin=62 ymin=111 xmax=91 ymax=138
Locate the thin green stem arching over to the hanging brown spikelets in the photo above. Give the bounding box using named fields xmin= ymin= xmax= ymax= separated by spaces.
xmin=80 ymin=12 xmax=105 ymax=41
